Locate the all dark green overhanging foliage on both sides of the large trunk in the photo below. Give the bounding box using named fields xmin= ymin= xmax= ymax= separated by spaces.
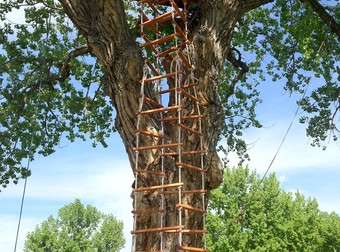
xmin=0 ymin=0 xmax=340 ymax=187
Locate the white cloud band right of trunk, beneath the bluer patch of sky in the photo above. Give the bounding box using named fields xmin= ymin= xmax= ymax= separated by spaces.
xmin=227 ymin=118 xmax=340 ymax=172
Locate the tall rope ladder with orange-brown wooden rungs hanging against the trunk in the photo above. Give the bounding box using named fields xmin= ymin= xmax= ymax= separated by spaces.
xmin=131 ymin=0 xmax=208 ymax=252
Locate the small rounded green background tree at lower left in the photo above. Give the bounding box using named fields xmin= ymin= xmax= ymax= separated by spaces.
xmin=24 ymin=199 xmax=125 ymax=252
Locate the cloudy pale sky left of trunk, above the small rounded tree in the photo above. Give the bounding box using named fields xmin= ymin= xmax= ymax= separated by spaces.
xmin=0 ymin=138 xmax=133 ymax=251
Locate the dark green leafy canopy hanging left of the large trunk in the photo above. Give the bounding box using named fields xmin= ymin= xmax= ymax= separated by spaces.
xmin=0 ymin=1 xmax=114 ymax=187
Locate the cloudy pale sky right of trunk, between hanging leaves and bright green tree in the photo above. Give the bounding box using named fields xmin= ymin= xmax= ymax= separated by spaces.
xmin=224 ymin=90 xmax=340 ymax=217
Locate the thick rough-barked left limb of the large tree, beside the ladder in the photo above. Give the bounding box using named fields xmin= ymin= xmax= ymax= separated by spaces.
xmin=59 ymin=0 xmax=143 ymax=163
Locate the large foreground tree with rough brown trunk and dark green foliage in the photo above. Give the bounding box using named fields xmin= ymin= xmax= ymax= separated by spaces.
xmin=0 ymin=0 xmax=340 ymax=251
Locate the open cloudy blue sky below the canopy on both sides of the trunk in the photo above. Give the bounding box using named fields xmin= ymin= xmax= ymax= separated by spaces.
xmin=0 ymin=78 xmax=340 ymax=252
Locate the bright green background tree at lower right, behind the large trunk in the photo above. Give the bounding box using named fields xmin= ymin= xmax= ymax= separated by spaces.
xmin=207 ymin=167 xmax=340 ymax=252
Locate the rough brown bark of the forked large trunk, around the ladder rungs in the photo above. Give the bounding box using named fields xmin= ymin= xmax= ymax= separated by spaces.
xmin=60 ymin=0 xmax=271 ymax=251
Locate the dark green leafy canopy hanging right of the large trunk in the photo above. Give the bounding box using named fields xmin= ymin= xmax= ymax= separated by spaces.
xmin=221 ymin=0 xmax=340 ymax=158
